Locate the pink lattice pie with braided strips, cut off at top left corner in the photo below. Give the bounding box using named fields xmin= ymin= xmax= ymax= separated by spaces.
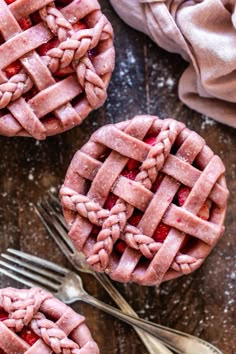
xmin=0 ymin=0 xmax=115 ymax=139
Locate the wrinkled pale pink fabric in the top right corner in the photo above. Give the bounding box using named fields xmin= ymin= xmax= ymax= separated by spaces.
xmin=110 ymin=0 xmax=236 ymax=128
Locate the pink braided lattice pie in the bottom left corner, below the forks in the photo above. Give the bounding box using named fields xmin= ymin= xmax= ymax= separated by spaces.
xmin=0 ymin=288 xmax=99 ymax=354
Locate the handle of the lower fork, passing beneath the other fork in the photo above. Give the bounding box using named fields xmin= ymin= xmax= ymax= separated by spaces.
xmin=94 ymin=273 xmax=172 ymax=354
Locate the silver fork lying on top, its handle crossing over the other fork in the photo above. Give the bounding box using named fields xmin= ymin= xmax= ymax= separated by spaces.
xmin=0 ymin=249 xmax=223 ymax=354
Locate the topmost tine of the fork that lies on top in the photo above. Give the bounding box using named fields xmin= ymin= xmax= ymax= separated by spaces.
xmin=7 ymin=248 xmax=69 ymax=275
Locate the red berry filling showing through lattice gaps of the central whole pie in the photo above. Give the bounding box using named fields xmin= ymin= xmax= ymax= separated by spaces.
xmin=101 ymin=136 xmax=211 ymax=254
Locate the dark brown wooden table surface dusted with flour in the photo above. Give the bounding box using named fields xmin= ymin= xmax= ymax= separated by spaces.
xmin=0 ymin=0 xmax=236 ymax=354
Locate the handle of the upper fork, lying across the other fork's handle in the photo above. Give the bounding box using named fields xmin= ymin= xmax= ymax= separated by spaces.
xmin=78 ymin=293 xmax=222 ymax=354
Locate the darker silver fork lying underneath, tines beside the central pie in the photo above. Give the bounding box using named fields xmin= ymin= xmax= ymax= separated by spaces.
xmin=35 ymin=193 xmax=172 ymax=354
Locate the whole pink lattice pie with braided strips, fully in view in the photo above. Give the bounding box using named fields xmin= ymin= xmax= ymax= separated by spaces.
xmin=60 ymin=116 xmax=228 ymax=285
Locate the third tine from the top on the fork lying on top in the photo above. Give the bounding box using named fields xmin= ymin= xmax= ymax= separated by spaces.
xmin=0 ymin=260 xmax=60 ymax=291
